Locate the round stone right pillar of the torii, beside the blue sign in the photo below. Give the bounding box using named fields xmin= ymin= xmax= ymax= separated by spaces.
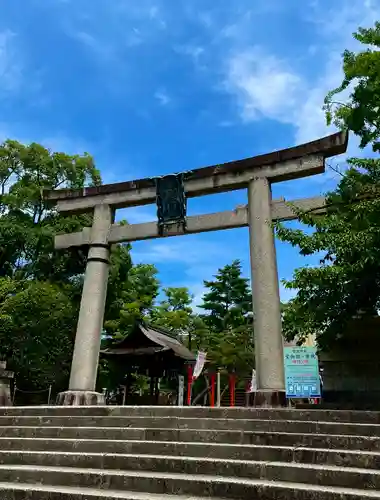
xmin=248 ymin=177 xmax=286 ymax=407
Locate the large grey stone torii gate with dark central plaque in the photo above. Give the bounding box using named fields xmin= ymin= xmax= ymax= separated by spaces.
xmin=44 ymin=132 xmax=348 ymax=406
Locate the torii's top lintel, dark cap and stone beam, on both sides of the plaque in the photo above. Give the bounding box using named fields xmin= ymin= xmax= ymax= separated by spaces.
xmin=44 ymin=132 xmax=348 ymax=212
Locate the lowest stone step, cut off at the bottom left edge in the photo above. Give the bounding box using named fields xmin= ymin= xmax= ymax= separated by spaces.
xmin=0 ymin=483 xmax=226 ymax=500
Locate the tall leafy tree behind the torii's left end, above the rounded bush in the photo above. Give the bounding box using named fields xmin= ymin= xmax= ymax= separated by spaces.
xmin=0 ymin=140 xmax=101 ymax=281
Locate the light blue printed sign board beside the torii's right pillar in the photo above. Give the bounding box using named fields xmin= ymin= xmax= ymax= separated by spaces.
xmin=284 ymin=347 xmax=321 ymax=399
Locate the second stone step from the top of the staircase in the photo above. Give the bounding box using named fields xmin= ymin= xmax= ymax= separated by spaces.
xmin=0 ymin=416 xmax=380 ymax=437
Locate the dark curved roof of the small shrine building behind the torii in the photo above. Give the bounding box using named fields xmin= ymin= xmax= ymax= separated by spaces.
xmin=100 ymin=322 xmax=195 ymax=361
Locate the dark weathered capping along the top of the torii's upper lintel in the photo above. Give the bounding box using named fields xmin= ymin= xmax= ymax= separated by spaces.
xmin=44 ymin=132 xmax=348 ymax=201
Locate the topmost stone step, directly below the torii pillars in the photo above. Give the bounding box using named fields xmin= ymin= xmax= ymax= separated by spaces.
xmin=0 ymin=406 xmax=380 ymax=424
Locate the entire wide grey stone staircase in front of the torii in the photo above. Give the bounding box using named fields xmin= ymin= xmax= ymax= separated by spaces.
xmin=0 ymin=406 xmax=380 ymax=500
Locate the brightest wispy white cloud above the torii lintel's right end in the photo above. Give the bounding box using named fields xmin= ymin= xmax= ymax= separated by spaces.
xmin=226 ymin=47 xmax=336 ymax=143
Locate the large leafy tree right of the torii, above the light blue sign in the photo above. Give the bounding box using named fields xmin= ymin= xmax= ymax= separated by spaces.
xmin=277 ymin=159 xmax=380 ymax=347
